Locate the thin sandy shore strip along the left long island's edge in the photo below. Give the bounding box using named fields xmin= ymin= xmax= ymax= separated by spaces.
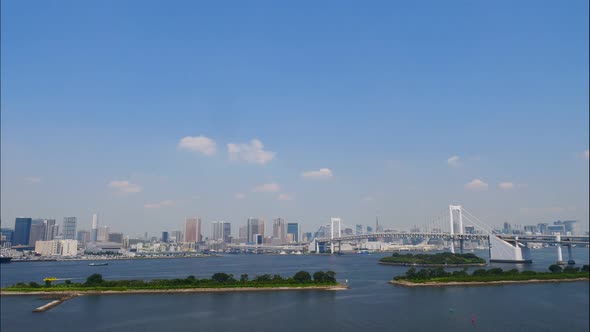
xmin=0 ymin=285 xmax=350 ymax=296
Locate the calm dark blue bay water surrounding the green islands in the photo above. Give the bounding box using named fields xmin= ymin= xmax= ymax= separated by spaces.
xmin=0 ymin=248 xmax=590 ymax=332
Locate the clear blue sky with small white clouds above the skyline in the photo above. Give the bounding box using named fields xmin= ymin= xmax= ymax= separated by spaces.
xmin=1 ymin=1 xmax=589 ymax=235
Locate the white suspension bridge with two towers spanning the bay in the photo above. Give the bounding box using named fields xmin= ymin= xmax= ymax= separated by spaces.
xmin=309 ymin=205 xmax=590 ymax=264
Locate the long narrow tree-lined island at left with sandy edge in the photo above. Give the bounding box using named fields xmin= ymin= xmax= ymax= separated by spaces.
xmin=1 ymin=271 xmax=348 ymax=295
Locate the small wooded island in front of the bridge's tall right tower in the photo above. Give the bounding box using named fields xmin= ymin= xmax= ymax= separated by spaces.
xmin=379 ymin=252 xmax=486 ymax=267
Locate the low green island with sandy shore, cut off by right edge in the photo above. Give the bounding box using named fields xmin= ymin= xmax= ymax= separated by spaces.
xmin=389 ymin=265 xmax=590 ymax=286
